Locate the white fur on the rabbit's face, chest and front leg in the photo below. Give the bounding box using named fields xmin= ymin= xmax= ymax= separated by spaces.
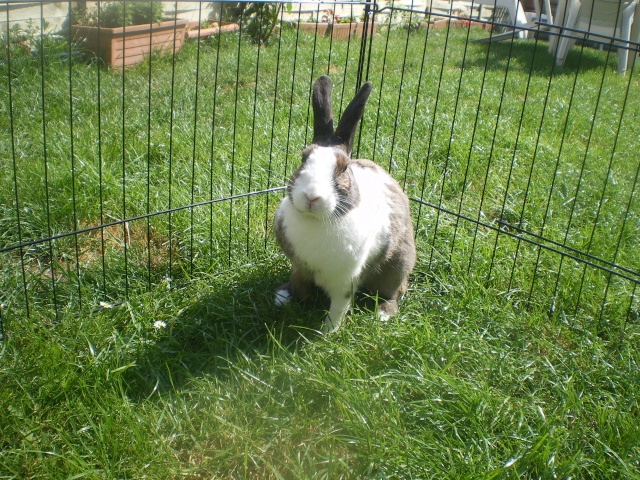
xmin=276 ymin=147 xmax=391 ymax=331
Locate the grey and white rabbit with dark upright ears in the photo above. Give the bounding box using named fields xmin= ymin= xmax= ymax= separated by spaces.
xmin=274 ymin=76 xmax=416 ymax=333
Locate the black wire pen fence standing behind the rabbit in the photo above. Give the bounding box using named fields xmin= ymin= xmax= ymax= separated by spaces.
xmin=0 ymin=1 xmax=640 ymax=338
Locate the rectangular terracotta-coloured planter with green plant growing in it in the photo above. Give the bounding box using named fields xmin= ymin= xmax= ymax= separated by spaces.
xmin=69 ymin=1 xmax=187 ymax=66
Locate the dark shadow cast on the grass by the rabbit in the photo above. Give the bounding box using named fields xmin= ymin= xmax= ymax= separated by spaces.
xmin=121 ymin=262 xmax=324 ymax=399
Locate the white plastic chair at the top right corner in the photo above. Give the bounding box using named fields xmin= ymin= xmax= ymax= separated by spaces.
xmin=549 ymin=0 xmax=640 ymax=74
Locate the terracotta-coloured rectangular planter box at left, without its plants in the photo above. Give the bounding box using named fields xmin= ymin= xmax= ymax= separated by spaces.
xmin=71 ymin=20 xmax=187 ymax=67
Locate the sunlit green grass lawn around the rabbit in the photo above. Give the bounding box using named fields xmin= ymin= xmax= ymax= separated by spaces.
xmin=0 ymin=16 xmax=640 ymax=479
